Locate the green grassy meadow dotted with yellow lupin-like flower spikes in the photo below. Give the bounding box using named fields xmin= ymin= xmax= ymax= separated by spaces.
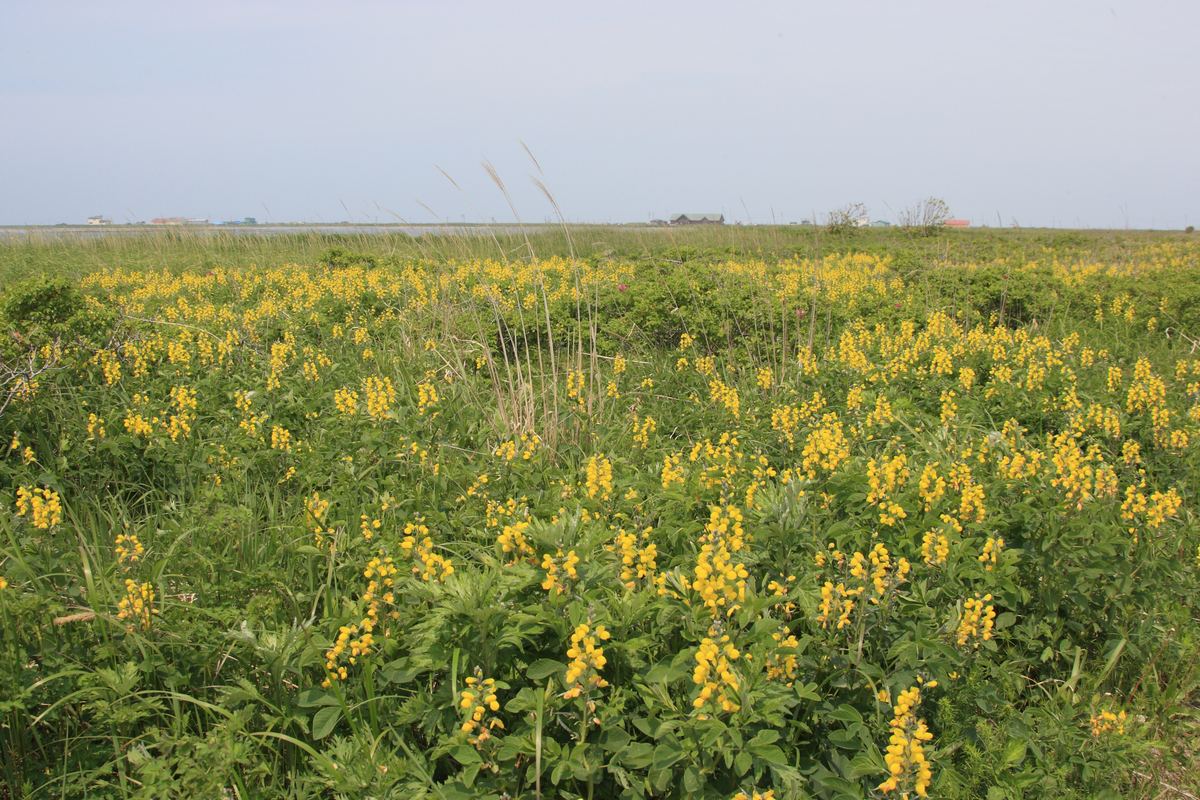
xmin=0 ymin=228 xmax=1200 ymax=800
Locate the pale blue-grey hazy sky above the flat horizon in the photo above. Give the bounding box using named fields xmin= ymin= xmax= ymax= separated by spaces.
xmin=0 ymin=0 xmax=1200 ymax=228
